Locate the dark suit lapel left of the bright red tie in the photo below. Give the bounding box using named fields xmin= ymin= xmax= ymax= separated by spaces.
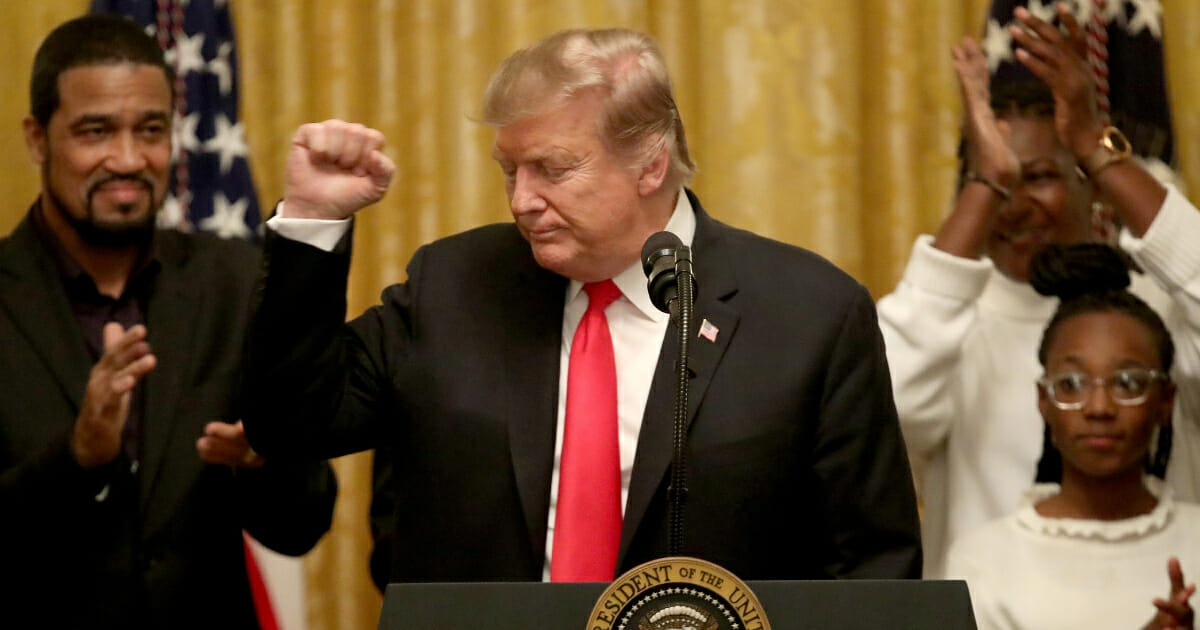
xmin=498 ymin=249 xmax=566 ymax=566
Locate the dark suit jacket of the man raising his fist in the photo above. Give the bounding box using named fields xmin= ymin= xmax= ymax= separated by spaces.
xmin=246 ymin=190 xmax=920 ymax=581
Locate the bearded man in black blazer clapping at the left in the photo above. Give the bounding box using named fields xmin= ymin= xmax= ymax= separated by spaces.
xmin=0 ymin=16 xmax=336 ymax=629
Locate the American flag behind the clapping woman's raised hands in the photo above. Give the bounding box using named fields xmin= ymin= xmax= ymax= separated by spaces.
xmin=980 ymin=0 xmax=1176 ymax=171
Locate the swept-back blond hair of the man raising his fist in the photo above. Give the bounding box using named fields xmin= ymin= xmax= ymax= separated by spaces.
xmin=482 ymin=29 xmax=696 ymax=184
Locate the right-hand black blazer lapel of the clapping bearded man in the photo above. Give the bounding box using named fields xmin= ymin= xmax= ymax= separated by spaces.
xmin=142 ymin=238 xmax=199 ymax=513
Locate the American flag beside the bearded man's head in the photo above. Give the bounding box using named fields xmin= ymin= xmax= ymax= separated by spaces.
xmin=91 ymin=0 xmax=260 ymax=239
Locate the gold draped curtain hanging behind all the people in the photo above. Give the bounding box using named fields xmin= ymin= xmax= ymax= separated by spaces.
xmin=0 ymin=0 xmax=1200 ymax=630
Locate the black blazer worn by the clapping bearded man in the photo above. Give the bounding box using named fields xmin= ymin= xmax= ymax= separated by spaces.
xmin=0 ymin=211 xmax=336 ymax=629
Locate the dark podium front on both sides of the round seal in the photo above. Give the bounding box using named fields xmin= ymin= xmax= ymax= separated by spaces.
xmin=379 ymin=580 xmax=976 ymax=630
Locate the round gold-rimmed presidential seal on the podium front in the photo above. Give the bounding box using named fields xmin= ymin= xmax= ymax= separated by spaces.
xmin=588 ymin=557 xmax=770 ymax=630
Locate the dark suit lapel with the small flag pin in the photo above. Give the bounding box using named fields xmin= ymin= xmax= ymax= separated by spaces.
xmin=618 ymin=198 xmax=740 ymax=559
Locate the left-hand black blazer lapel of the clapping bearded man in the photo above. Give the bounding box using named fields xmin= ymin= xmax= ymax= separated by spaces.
xmin=0 ymin=215 xmax=94 ymax=412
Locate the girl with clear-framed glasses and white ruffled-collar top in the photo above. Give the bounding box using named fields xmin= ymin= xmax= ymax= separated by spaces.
xmin=947 ymin=244 xmax=1200 ymax=630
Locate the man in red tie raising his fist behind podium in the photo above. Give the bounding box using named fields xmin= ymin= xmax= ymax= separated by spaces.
xmin=246 ymin=29 xmax=920 ymax=581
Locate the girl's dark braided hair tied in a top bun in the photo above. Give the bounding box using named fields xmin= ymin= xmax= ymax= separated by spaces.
xmin=1030 ymin=242 xmax=1175 ymax=482
